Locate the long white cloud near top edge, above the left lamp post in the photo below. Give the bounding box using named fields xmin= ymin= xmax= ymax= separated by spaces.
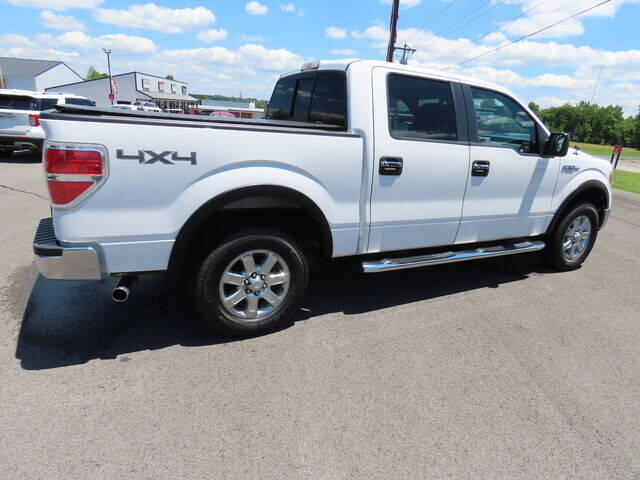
xmin=93 ymin=3 xmax=216 ymax=33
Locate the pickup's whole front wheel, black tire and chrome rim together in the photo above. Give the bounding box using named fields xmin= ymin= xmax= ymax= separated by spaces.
xmin=544 ymin=203 xmax=600 ymax=270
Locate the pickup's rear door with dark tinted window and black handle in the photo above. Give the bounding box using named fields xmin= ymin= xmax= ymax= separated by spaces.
xmin=368 ymin=68 xmax=469 ymax=252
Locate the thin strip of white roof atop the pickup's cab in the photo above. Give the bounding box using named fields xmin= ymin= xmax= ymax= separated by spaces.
xmin=282 ymin=58 xmax=516 ymax=97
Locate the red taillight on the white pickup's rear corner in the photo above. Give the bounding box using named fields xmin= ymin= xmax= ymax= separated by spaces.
xmin=43 ymin=143 xmax=106 ymax=207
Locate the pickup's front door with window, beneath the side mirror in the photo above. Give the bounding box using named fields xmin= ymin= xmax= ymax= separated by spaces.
xmin=456 ymin=85 xmax=560 ymax=243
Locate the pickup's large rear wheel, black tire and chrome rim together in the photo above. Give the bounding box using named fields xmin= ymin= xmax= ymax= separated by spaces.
xmin=195 ymin=230 xmax=309 ymax=336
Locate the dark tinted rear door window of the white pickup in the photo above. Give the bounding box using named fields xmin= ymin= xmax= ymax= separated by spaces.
xmin=388 ymin=75 xmax=458 ymax=141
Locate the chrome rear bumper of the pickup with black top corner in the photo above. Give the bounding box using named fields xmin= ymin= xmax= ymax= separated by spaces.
xmin=33 ymin=218 xmax=102 ymax=280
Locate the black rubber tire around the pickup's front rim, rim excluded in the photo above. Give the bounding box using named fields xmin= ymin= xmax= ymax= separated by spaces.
xmin=543 ymin=202 xmax=600 ymax=271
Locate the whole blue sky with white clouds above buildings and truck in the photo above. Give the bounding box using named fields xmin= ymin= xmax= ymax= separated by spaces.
xmin=0 ymin=0 xmax=640 ymax=115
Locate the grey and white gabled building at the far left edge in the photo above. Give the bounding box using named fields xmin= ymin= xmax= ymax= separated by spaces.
xmin=0 ymin=57 xmax=82 ymax=92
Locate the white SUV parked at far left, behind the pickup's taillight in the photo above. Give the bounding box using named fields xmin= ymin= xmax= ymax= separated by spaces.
xmin=0 ymin=89 xmax=95 ymax=155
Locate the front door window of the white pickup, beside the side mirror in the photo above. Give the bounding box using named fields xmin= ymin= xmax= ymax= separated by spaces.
xmin=471 ymin=87 xmax=538 ymax=153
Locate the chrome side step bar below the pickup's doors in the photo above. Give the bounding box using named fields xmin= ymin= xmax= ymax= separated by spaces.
xmin=362 ymin=242 xmax=545 ymax=273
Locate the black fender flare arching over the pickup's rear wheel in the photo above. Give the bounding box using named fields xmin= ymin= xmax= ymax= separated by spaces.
xmin=168 ymin=185 xmax=333 ymax=272
